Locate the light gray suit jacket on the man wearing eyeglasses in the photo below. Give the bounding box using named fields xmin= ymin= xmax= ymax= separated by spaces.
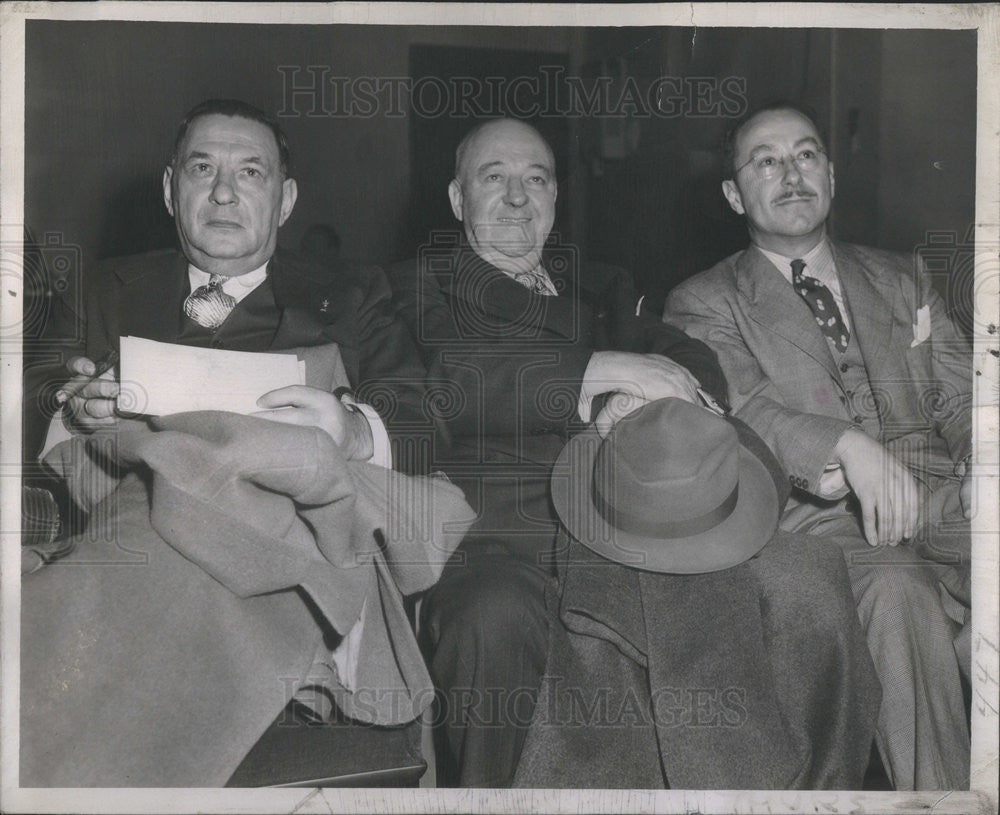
xmin=664 ymin=242 xmax=972 ymax=528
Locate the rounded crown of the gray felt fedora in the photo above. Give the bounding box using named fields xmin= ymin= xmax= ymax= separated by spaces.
xmin=592 ymin=399 xmax=740 ymax=529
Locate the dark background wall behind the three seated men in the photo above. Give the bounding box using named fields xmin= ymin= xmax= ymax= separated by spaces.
xmin=25 ymin=21 xmax=976 ymax=320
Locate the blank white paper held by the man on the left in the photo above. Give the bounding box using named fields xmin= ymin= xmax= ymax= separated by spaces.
xmin=118 ymin=337 xmax=305 ymax=416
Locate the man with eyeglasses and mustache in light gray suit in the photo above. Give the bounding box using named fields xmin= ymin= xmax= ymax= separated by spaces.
xmin=664 ymin=103 xmax=972 ymax=790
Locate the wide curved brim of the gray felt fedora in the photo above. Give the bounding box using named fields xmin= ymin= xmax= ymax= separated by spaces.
xmin=551 ymin=429 xmax=778 ymax=574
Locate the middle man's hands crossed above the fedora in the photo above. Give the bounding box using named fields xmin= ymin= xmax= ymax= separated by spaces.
xmin=578 ymin=351 xmax=700 ymax=436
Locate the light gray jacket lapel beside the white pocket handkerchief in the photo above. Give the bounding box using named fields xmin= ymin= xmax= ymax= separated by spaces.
xmin=831 ymin=244 xmax=898 ymax=377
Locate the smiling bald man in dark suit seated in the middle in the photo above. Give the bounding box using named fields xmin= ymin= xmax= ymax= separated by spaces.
xmin=389 ymin=120 xmax=725 ymax=786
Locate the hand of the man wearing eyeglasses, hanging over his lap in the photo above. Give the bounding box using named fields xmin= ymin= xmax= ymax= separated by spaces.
xmin=834 ymin=427 xmax=920 ymax=546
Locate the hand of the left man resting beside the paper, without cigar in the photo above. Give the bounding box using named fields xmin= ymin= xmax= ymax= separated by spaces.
xmin=252 ymin=385 xmax=374 ymax=461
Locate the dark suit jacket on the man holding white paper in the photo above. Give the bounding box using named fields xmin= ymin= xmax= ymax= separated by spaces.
xmin=87 ymin=249 xmax=430 ymax=471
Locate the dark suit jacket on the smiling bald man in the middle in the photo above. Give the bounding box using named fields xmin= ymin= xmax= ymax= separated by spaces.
xmin=388 ymin=239 xmax=726 ymax=559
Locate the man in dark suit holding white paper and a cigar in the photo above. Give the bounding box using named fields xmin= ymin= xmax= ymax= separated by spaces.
xmin=62 ymin=100 xmax=423 ymax=466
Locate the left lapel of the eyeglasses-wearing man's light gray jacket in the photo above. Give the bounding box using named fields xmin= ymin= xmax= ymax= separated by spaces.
xmin=736 ymin=246 xmax=840 ymax=382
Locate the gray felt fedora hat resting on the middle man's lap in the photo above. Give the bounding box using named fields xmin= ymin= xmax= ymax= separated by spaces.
xmin=552 ymin=398 xmax=779 ymax=574
